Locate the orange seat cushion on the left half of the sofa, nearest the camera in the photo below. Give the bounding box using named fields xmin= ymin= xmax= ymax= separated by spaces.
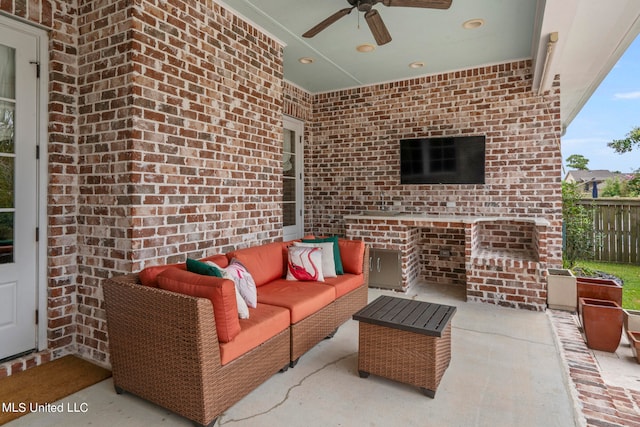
xmin=220 ymin=304 xmax=289 ymax=365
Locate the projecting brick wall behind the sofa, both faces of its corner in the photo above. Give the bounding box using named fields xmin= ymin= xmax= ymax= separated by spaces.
xmin=77 ymin=0 xmax=283 ymax=362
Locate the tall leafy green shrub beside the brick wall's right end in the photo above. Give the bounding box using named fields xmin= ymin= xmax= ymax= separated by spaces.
xmin=562 ymin=181 xmax=597 ymax=268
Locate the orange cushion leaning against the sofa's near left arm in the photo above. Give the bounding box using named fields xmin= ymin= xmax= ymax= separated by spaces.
xmin=158 ymin=268 xmax=240 ymax=342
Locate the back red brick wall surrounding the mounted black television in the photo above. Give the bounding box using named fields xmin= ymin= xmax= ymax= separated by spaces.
xmin=306 ymin=61 xmax=562 ymax=266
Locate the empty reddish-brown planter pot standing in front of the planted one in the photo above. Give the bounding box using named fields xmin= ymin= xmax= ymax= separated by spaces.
xmin=580 ymin=298 xmax=623 ymax=353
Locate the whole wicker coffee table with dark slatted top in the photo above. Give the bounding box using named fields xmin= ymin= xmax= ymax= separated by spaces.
xmin=353 ymin=296 xmax=456 ymax=398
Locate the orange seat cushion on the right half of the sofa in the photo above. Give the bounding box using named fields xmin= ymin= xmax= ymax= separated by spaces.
xmin=258 ymin=279 xmax=336 ymax=324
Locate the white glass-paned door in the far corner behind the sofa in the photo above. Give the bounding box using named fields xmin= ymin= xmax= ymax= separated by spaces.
xmin=282 ymin=117 xmax=304 ymax=241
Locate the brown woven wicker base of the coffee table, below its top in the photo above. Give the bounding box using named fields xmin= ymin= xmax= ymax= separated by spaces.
xmin=358 ymin=322 xmax=451 ymax=397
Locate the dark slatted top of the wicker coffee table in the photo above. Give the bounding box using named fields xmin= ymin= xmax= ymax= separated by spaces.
xmin=353 ymin=295 xmax=456 ymax=337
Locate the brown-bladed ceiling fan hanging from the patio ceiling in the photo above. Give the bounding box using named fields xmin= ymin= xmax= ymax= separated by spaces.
xmin=302 ymin=0 xmax=452 ymax=45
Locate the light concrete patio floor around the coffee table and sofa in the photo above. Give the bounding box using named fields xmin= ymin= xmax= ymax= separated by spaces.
xmin=6 ymin=284 xmax=584 ymax=427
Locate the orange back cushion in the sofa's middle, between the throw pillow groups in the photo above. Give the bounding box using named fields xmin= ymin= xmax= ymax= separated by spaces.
xmin=227 ymin=242 xmax=284 ymax=287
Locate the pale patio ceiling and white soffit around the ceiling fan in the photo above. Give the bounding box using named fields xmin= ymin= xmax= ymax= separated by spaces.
xmin=219 ymin=0 xmax=640 ymax=130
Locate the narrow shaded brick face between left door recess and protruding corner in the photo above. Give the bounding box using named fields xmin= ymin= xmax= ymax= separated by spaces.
xmin=76 ymin=0 xmax=135 ymax=368
